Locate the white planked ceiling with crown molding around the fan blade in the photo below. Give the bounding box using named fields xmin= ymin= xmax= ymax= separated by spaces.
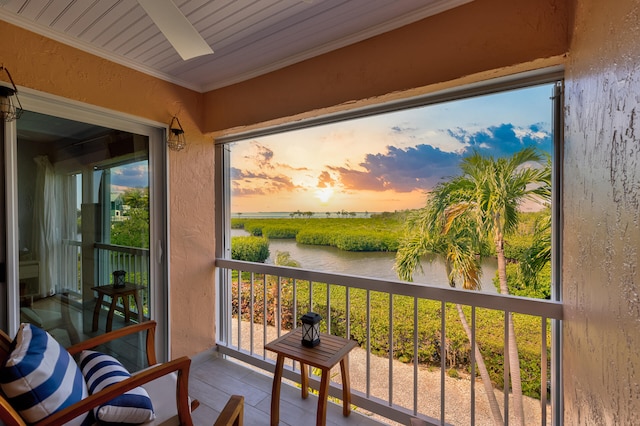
xmin=0 ymin=0 xmax=472 ymax=92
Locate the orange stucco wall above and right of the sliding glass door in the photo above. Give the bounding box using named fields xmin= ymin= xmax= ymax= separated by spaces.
xmin=0 ymin=21 xmax=215 ymax=357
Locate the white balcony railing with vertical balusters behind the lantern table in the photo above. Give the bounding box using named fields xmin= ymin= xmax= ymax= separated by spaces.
xmin=216 ymin=259 xmax=562 ymax=425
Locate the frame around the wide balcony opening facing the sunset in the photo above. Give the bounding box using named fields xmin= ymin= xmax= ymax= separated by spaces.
xmin=214 ymin=66 xmax=564 ymax=340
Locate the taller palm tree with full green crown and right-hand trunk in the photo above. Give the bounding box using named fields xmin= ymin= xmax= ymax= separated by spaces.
xmin=442 ymin=147 xmax=551 ymax=425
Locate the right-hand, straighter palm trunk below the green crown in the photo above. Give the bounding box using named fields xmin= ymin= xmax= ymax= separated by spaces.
xmin=495 ymin=232 xmax=524 ymax=426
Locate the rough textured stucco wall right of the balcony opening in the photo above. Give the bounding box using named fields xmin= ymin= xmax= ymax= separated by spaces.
xmin=563 ymin=0 xmax=640 ymax=425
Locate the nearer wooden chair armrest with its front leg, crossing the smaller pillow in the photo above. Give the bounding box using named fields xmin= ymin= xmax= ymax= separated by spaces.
xmin=34 ymin=356 xmax=193 ymax=426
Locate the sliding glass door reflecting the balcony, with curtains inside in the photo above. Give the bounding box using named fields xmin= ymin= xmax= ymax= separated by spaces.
xmin=5 ymin=98 xmax=167 ymax=368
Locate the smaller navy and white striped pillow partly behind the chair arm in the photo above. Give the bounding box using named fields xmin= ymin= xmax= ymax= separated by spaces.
xmin=79 ymin=351 xmax=155 ymax=424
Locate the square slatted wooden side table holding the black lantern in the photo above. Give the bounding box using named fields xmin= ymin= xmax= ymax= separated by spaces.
xmin=265 ymin=328 xmax=358 ymax=426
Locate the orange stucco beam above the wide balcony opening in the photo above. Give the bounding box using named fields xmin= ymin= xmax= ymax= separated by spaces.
xmin=204 ymin=0 xmax=571 ymax=132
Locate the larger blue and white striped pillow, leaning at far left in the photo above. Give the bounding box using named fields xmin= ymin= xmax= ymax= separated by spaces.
xmin=0 ymin=323 xmax=93 ymax=425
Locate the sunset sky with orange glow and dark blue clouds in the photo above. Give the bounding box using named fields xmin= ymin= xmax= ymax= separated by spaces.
xmin=231 ymin=85 xmax=552 ymax=213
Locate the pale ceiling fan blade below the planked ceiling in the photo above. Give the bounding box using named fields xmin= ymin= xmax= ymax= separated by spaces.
xmin=138 ymin=0 xmax=213 ymax=61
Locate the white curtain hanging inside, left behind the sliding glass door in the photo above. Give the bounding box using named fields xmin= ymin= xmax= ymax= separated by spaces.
xmin=33 ymin=155 xmax=61 ymax=297
